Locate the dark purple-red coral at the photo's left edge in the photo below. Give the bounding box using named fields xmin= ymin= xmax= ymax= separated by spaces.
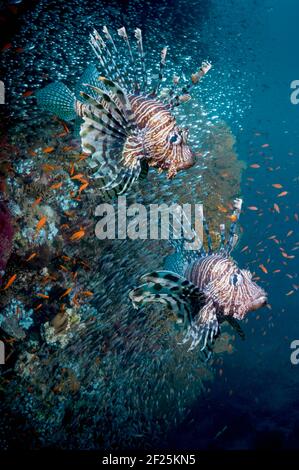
xmin=0 ymin=202 xmax=14 ymax=274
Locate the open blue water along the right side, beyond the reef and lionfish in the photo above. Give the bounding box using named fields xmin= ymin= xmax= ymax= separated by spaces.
xmin=173 ymin=0 xmax=299 ymax=449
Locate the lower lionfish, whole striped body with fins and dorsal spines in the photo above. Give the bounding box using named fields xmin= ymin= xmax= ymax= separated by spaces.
xmin=129 ymin=199 xmax=267 ymax=351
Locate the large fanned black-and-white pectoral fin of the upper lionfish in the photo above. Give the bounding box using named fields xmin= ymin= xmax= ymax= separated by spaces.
xmin=80 ymin=77 xmax=143 ymax=195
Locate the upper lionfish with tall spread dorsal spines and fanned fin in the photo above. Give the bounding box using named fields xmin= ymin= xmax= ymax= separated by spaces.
xmin=36 ymin=26 xmax=211 ymax=194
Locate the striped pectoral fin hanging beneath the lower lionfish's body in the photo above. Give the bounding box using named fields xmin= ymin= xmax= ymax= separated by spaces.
xmin=182 ymin=302 xmax=219 ymax=351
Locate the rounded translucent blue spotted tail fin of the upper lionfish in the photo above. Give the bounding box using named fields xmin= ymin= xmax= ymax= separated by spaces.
xmin=35 ymin=82 xmax=77 ymax=121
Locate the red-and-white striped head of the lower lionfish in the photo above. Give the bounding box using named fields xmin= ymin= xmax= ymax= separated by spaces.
xmin=210 ymin=259 xmax=267 ymax=320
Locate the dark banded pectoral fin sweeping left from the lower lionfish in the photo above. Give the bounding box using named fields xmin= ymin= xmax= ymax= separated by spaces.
xmin=129 ymin=271 xmax=203 ymax=325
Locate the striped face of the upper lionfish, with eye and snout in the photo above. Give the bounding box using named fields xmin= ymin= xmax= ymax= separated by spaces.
xmin=168 ymin=126 xmax=195 ymax=178
